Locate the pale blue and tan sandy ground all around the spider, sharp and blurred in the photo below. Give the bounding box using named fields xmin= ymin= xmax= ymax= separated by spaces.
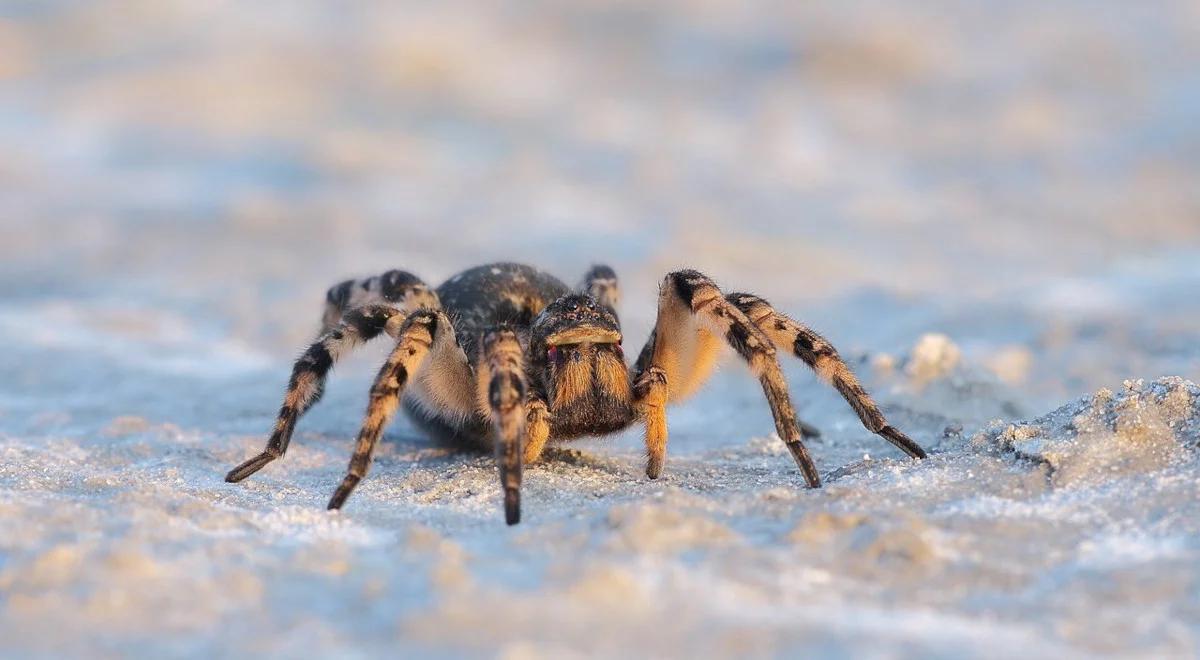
xmin=0 ymin=0 xmax=1200 ymax=658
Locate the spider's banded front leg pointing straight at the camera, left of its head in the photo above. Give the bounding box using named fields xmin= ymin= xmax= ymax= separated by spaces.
xmin=475 ymin=328 xmax=529 ymax=524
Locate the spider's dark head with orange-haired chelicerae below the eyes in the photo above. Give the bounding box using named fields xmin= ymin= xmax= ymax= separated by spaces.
xmin=530 ymin=294 xmax=632 ymax=438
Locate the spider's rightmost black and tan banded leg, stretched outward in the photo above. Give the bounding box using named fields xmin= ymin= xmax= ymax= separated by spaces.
xmin=727 ymin=293 xmax=925 ymax=458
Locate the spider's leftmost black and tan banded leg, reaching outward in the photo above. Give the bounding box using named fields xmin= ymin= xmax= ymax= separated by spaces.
xmin=226 ymin=305 xmax=404 ymax=484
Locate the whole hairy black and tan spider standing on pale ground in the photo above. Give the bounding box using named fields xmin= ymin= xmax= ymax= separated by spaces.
xmin=226 ymin=264 xmax=925 ymax=524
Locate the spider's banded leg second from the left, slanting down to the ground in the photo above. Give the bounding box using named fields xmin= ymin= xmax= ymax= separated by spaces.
xmin=329 ymin=310 xmax=455 ymax=509
